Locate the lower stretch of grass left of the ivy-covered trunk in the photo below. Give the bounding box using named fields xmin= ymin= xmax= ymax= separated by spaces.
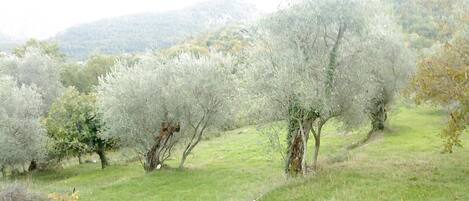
xmin=3 ymin=126 xmax=283 ymax=201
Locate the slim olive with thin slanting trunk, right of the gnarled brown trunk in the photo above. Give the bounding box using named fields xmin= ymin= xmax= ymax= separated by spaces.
xmin=167 ymin=53 xmax=237 ymax=168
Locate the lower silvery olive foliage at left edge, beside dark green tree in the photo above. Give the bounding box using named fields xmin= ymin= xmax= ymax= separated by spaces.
xmin=0 ymin=76 xmax=46 ymax=166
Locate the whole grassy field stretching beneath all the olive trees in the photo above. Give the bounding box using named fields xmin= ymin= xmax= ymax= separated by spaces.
xmin=3 ymin=108 xmax=469 ymax=201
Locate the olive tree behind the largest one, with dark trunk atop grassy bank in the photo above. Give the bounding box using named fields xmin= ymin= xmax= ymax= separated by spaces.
xmin=340 ymin=13 xmax=415 ymax=149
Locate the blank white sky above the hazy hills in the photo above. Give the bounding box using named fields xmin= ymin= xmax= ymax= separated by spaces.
xmin=0 ymin=0 xmax=280 ymax=39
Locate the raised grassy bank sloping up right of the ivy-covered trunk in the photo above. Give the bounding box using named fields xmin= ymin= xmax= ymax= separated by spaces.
xmin=262 ymin=108 xmax=469 ymax=201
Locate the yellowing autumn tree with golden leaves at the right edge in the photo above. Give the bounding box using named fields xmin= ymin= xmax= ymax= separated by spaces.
xmin=412 ymin=26 xmax=469 ymax=152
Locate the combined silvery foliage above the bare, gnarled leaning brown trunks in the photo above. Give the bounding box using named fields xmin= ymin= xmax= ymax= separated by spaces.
xmin=97 ymin=53 xmax=235 ymax=162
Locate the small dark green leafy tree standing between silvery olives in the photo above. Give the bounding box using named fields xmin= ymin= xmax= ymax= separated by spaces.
xmin=45 ymin=87 xmax=112 ymax=168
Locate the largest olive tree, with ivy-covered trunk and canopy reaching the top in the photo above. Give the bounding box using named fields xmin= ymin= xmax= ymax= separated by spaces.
xmin=247 ymin=0 xmax=406 ymax=174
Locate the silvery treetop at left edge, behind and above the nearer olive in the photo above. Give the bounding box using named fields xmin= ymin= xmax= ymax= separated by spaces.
xmin=0 ymin=48 xmax=63 ymax=111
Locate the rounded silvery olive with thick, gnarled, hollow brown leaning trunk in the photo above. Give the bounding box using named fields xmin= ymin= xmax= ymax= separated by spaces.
xmin=97 ymin=56 xmax=181 ymax=171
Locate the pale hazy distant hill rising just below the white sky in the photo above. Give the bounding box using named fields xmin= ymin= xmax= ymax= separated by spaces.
xmin=52 ymin=0 xmax=259 ymax=59
